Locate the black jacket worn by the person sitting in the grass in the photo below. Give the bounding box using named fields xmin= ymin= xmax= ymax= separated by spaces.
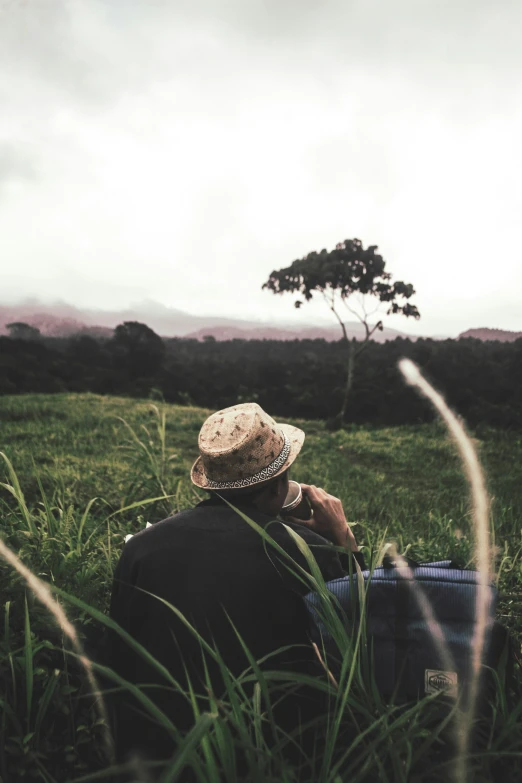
xmin=108 ymin=496 xmax=364 ymax=757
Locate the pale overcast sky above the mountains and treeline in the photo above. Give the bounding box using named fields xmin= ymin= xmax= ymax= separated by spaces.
xmin=0 ymin=0 xmax=522 ymax=335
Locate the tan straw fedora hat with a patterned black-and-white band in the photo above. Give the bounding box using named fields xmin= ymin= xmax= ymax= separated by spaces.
xmin=190 ymin=402 xmax=305 ymax=490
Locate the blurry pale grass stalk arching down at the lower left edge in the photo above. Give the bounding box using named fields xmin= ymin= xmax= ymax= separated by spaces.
xmin=0 ymin=539 xmax=114 ymax=763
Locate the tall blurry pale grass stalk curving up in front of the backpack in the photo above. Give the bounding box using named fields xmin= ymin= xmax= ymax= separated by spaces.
xmin=399 ymin=359 xmax=491 ymax=783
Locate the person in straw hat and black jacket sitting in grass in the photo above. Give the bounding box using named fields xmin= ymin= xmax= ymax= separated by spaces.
xmin=107 ymin=403 xmax=364 ymax=759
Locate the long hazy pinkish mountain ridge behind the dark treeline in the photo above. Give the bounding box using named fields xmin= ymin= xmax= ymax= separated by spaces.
xmin=0 ymin=300 xmax=417 ymax=342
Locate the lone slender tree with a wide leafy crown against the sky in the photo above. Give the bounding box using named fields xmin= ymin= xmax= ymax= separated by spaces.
xmin=263 ymin=239 xmax=420 ymax=426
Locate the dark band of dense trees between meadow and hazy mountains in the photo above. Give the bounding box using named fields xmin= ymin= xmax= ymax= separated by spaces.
xmin=0 ymin=324 xmax=522 ymax=428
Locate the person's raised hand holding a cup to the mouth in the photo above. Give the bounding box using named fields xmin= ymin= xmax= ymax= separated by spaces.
xmin=284 ymin=484 xmax=359 ymax=552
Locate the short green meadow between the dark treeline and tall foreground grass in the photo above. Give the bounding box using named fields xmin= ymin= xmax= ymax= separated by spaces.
xmin=0 ymin=394 xmax=522 ymax=572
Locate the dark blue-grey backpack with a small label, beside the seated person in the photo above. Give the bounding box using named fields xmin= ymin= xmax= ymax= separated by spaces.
xmin=305 ymin=560 xmax=507 ymax=702
